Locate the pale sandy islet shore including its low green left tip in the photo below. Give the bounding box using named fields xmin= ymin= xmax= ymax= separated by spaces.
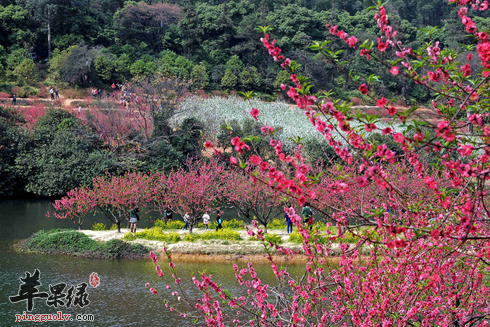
xmin=14 ymin=228 xmax=352 ymax=265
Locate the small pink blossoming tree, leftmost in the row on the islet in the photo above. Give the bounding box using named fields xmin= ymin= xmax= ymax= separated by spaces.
xmin=47 ymin=187 xmax=96 ymax=230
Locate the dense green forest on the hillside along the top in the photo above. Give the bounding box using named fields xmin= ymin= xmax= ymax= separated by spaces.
xmin=0 ymin=0 xmax=490 ymax=104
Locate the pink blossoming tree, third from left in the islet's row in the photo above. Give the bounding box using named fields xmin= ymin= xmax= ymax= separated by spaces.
xmin=159 ymin=160 xmax=227 ymax=234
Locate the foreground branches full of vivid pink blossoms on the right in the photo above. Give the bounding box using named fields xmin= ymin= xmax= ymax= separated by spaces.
xmin=145 ymin=0 xmax=490 ymax=327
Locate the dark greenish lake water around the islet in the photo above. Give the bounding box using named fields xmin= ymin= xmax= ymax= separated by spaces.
xmin=0 ymin=200 xmax=301 ymax=327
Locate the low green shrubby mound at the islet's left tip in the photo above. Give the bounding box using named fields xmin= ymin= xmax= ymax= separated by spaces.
xmin=17 ymin=229 xmax=150 ymax=259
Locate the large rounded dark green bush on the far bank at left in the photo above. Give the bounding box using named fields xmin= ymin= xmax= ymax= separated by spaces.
xmin=16 ymin=109 xmax=115 ymax=196
